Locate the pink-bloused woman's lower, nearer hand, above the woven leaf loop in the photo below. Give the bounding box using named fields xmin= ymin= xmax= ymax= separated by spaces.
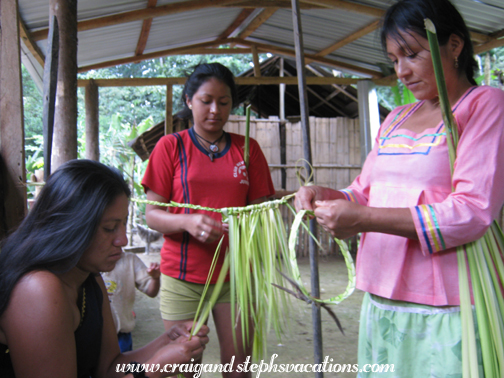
xmin=315 ymin=199 xmax=368 ymax=239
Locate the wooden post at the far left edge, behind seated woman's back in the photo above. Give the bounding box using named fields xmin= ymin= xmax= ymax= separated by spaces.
xmin=0 ymin=0 xmax=27 ymax=233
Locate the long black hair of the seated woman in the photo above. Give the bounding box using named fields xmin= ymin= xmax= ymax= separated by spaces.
xmin=0 ymin=160 xmax=131 ymax=315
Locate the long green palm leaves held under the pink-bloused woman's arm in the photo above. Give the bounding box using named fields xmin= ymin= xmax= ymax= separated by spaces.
xmin=425 ymin=19 xmax=504 ymax=378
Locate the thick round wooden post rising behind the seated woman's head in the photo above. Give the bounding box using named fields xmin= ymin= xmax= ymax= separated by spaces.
xmin=49 ymin=0 xmax=77 ymax=169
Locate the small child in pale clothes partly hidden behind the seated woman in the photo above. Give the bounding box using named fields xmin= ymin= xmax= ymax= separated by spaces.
xmin=102 ymin=252 xmax=161 ymax=353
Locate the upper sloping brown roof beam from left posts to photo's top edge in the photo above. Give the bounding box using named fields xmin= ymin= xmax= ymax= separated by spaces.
xmin=32 ymin=0 xmax=245 ymax=41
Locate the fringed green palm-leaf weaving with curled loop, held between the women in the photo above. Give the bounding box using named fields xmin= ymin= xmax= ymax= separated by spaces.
xmin=134 ymin=194 xmax=355 ymax=360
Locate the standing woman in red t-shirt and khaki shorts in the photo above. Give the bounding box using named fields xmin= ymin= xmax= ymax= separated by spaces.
xmin=142 ymin=63 xmax=274 ymax=377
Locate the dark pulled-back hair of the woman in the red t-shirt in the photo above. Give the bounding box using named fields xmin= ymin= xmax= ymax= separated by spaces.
xmin=178 ymin=63 xmax=238 ymax=118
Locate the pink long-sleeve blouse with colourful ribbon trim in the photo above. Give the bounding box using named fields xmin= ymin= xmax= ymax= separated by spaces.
xmin=342 ymin=86 xmax=504 ymax=306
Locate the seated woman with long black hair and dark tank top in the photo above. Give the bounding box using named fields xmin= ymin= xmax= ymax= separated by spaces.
xmin=0 ymin=160 xmax=208 ymax=378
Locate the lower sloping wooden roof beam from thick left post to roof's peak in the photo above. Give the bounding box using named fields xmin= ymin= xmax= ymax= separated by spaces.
xmin=78 ymin=39 xmax=237 ymax=73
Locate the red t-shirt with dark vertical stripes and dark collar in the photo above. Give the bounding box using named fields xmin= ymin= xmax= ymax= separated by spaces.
xmin=142 ymin=128 xmax=275 ymax=283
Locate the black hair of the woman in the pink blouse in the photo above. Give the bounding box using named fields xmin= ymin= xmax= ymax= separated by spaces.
xmin=381 ymin=0 xmax=478 ymax=85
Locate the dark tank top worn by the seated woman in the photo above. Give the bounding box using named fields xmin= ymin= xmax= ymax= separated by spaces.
xmin=0 ymin=274 xmax=103 ymax=378
